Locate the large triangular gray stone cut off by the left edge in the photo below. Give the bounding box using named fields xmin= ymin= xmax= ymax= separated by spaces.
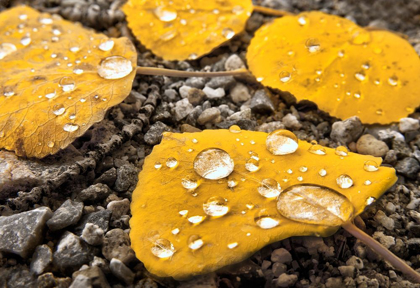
xmin=0 ymin=207 xmax=52 ymax=258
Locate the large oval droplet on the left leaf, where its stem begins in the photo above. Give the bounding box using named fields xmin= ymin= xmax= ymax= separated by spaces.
xmin=98 ymin=56 xmax=133 ymax=79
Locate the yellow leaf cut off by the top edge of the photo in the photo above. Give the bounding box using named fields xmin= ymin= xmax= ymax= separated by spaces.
xmin=123 ymin=0 xmax=252 ymax=60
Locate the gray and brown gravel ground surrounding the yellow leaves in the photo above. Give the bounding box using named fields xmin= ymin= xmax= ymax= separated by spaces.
xmin=0 ymin=0 xmax=420 ymax=288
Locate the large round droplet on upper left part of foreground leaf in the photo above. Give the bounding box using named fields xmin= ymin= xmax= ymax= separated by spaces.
xmin=193 ymin=148 xmax=234 ymax=180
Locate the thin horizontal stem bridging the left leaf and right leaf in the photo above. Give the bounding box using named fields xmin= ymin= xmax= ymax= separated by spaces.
xmin=136 ymin=67 xmax=250 ymax=77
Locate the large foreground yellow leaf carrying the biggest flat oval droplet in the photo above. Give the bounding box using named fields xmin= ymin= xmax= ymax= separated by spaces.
xmin=130 ymin=126 xmax=397 ymax=279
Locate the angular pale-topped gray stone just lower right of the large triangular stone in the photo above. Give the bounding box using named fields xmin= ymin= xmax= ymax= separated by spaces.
xmin=53 ymin=231 xmax=93 ymax=274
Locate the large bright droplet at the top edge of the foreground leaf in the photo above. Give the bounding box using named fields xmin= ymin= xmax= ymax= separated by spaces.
xmin=265 ymin=129 xmax=299 ymax=155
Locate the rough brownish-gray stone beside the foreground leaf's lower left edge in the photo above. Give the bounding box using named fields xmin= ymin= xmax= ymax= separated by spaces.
xmin=102 ymin=228 xmax=135 ymax=265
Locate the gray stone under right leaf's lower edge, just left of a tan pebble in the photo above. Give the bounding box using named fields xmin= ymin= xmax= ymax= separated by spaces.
xmin=331 ymin=116 xmax=364 ymax=145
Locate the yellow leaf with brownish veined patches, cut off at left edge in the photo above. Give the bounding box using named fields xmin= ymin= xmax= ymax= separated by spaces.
xmin=0 ymin=6 xmax=137 ymax=158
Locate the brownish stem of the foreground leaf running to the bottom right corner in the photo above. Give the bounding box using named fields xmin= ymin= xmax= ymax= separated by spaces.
xmin=342 ymin=222 xmax=420 ymax=283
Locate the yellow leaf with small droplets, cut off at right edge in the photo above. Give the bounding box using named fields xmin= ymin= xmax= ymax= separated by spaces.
xmin=247 ymin=12 xmax=420 ymax=124
